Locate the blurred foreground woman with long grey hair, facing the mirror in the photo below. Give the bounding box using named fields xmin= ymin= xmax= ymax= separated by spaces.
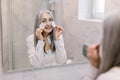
xmin=84 ymin=12 xmax=120 ymax=80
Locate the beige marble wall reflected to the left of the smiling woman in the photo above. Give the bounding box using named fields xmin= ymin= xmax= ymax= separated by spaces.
xmin=1 ymin=0 xmax=49 ymax=70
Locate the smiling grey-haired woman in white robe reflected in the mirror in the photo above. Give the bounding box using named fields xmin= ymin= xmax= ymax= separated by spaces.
xmin=26 ymin=11 xmax=67 ymax=67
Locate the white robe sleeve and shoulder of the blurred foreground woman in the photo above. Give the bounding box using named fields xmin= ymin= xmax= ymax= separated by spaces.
xmin=80 ymin=65 xmax=120 ymax=80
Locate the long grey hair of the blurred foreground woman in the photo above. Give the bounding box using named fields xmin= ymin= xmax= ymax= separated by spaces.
xmin=95 ymin=11 xmax=120 ymax=80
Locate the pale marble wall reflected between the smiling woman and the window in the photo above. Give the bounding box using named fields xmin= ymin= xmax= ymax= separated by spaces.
xmin=62 ymin=0 xmax=102 ymax=62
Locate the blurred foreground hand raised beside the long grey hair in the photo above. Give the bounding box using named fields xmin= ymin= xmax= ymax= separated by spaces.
xmin=87 ymin=44 xmax=100 ymax=68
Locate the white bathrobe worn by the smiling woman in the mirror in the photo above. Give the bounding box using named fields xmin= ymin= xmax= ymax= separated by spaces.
xmin=26 ymin=34 xmax=67 ymax=67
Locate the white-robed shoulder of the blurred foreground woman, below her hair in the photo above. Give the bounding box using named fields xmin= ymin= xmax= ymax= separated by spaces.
xmin=97 ymin=67 xmax=120 ymax=80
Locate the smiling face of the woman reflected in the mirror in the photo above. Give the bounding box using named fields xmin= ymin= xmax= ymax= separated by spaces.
xmin=41 ymin=13 xmax=53 ymax=33
